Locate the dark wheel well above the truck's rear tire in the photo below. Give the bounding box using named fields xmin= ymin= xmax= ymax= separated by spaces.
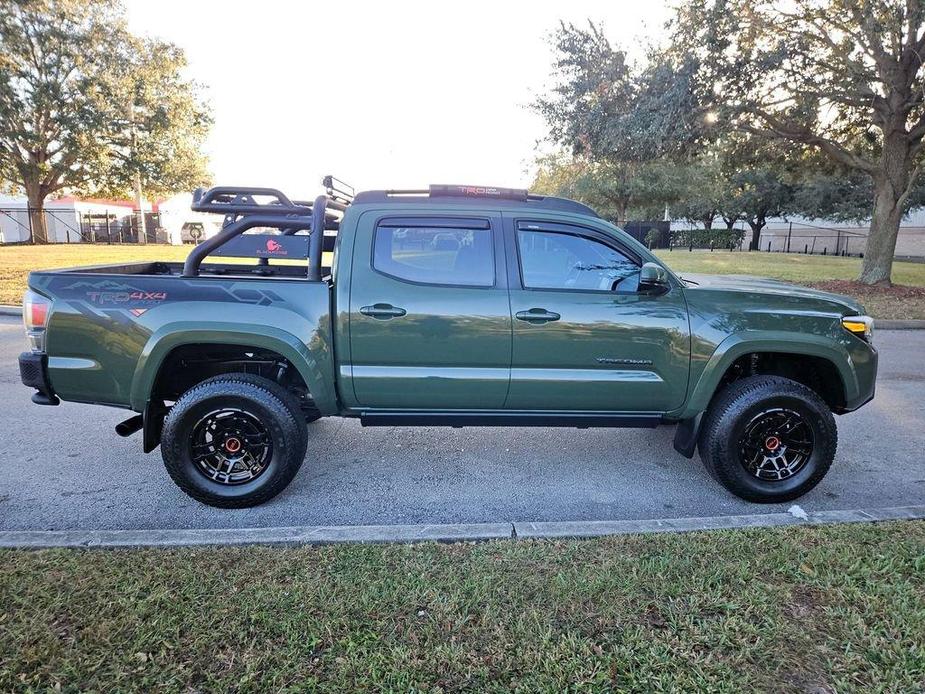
xmin=150 ymin=343 xmax=319 ymax=420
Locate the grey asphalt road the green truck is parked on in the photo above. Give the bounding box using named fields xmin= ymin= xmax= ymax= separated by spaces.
xmin=0 ymin=317 xmax=925 ymax=530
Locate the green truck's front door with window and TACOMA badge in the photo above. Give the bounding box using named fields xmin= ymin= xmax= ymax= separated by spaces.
xmin=505 ymin=219 xmax=690 ymax=412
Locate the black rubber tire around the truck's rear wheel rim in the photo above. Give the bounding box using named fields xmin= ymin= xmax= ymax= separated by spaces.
xmin=161 ymin=373 xmax=308 ymax=508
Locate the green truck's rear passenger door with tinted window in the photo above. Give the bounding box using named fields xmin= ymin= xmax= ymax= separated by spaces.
xmin=349 ymin=212 xmax=511 ymax=409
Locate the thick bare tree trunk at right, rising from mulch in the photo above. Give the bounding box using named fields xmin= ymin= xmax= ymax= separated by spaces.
xmin=858 ymin=133 xmax=912 ymax=286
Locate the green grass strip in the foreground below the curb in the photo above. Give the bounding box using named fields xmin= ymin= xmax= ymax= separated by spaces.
xmin=0 ymin=521 xmax=925 ymax=692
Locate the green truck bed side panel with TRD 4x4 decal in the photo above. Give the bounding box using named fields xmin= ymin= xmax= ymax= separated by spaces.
xmin=29 ymin=261 xmax=333 ymax=412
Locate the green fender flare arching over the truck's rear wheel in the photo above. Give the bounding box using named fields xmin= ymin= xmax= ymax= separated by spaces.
xmin=131 ymin=322 xmax=338 ymax=415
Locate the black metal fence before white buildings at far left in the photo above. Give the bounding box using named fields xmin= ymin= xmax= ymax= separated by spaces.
xmin=0 ymin=207 xmax=169 ymax=245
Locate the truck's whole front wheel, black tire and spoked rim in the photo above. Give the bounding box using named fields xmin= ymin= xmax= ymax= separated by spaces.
xmin=698 ymin=376 xmax=838 ymax=503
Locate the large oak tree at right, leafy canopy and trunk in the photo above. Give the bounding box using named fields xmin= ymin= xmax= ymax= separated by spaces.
xmin=673 ymin=0 xmax=925 ymax=284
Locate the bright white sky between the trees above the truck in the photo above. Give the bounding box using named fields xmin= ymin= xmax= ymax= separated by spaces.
xmin=127 ymin=0 xmax=668 ymax=197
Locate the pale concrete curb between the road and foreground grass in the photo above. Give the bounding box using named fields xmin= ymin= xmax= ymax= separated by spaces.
xmin=0 ymin=506 xmax=925 ymax=549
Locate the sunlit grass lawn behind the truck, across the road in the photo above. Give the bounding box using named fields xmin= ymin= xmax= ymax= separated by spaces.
xmin=0 ymin=244 xmax=925 ymax=319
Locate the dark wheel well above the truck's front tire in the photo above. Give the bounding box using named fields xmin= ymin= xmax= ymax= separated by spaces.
xmin=714 ymin=352 xmax=845 ymax=412
